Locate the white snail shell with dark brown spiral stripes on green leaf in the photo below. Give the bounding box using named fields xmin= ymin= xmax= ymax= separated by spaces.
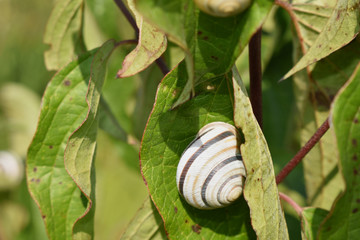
xmin=176 ymin=122 xmax=246 ymax=209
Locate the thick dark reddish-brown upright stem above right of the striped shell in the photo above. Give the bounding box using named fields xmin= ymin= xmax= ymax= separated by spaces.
xmin=249 ymin=28 xmax=262 ymax=128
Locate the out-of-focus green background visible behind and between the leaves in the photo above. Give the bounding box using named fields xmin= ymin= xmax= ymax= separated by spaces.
xmin=0 ymin=0 xmax=305 ymax=240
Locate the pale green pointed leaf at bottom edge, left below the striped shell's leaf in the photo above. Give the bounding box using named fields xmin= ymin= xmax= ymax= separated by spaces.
xmin=120 ymin=198 xmax=167 ymax=240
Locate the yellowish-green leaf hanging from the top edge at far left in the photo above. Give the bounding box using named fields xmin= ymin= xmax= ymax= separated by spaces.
xmin=44 ymin=0 xmax=86 ymax=70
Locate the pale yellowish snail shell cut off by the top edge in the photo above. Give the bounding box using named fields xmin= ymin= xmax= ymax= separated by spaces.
xmin=194 ymin=0 xmax=251 ymax=17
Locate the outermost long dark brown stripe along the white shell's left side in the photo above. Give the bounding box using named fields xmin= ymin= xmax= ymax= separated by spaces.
xmin=179 ymin=131 xmax=234 ymax=196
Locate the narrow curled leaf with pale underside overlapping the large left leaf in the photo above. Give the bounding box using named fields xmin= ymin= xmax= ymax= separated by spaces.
xmin=64 ymin=40 xmax=115 ymax=239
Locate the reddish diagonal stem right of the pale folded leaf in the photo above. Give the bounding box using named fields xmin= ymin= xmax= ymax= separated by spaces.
xmin=276 ymin=118 xmax=330 ymax=184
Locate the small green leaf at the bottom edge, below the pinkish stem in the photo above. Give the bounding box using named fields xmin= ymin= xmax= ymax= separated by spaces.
xmin=301 ymin=207 xmax=329 ymax=240
